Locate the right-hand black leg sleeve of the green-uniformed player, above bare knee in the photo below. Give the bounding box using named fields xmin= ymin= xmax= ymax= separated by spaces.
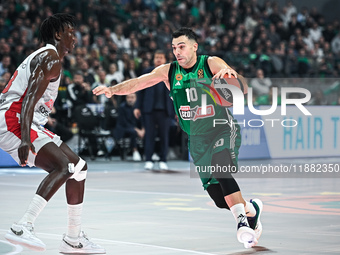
xmin=211 ymin=149 xmax=240 ymax=196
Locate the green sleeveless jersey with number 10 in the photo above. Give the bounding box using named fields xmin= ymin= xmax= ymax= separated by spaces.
xmin=169 ymin=55 xmax=239 ymax=135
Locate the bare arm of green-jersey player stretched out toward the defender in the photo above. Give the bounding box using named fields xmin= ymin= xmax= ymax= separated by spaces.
xmin=92 ymin=64 xmax=170 ymax=98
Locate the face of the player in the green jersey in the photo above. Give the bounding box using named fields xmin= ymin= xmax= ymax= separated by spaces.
xmin=172 ymin=35 xmax=198 ymax=68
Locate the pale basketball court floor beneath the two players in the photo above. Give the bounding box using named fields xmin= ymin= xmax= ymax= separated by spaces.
xmin=0 ymin=158 xmax=340 ymax=255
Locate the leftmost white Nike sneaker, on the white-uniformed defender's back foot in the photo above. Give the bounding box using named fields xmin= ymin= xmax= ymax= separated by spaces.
xmin=5 ymin=222 xmax=46 ymax=251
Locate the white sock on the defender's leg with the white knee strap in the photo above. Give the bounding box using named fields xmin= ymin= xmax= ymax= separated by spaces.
xmin=67 ymin=203 xmax=83 ymax=239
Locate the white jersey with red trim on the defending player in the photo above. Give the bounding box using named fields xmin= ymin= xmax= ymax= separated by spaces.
xmin=0 ymin=44 xmax=60 ymax=125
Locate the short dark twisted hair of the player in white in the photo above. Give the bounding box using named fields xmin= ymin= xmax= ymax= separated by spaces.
xmin=39 ymin=13 xmax=76 ymax=43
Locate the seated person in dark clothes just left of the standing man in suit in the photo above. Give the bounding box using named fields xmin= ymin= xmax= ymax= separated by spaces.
xmin=113 ymin=93 xmax=145 ymax=161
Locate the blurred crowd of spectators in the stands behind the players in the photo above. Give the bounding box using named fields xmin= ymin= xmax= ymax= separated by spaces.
xmin=0 ymin=0 xmax=340 ymax=159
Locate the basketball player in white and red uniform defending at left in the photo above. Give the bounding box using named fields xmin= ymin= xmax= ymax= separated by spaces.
xmin=0 ymin=14 xmax=105 ymax=254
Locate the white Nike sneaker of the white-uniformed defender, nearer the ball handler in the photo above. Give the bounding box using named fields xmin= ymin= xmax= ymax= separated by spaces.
xmin=59 ymin=231 xmax=106 ymax=254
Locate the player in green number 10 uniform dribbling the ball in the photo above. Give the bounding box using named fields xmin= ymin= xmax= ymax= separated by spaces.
xmin=93 ymin=28 xmax=263 ymax=248
